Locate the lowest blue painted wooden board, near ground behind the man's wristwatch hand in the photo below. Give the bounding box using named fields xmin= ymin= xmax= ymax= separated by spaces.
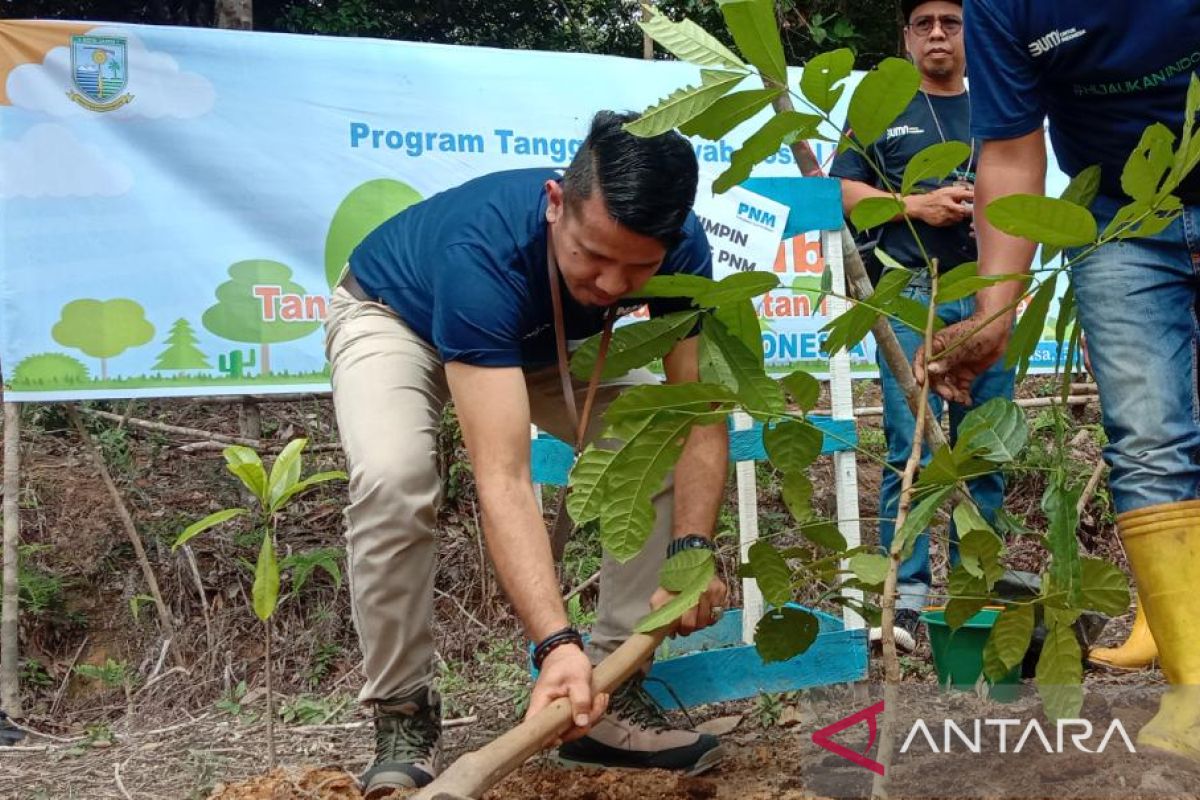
xmin=646 ymin=609 xmax=868 ymax=709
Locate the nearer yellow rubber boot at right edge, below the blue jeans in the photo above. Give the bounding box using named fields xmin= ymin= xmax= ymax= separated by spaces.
xmin=1117 ymin=500 xmax=1200 ymax=763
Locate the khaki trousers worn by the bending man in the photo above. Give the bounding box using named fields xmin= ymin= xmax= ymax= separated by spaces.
xmin=325 ymin=287 xmax=674 ymax=703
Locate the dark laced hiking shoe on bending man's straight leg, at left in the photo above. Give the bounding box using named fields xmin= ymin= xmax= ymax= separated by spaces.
xmin=359 ymin=686 xmax=442 ymax=800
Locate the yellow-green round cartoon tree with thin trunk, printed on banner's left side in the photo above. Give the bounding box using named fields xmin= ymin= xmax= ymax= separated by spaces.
xmin=50 ymin=297 xmax=154 ymax=380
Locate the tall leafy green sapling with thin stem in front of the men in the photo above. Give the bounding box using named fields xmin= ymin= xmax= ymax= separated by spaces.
xmin=578 ymin=0 xmax=1200 ymax=717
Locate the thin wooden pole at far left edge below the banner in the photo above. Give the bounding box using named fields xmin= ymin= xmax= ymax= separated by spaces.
xmin=0 ymin=403 xmax=20 ymax=716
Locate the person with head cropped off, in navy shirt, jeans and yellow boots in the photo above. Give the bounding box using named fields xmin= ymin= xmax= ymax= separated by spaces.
xmin=914 ymin=0 xmax=1200 ymax=762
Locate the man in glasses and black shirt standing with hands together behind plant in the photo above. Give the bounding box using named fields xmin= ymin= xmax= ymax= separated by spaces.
xmin=830 ymin=0 xmax=1013 ymax=650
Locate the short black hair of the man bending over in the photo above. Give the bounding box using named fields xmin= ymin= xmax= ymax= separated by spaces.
xmin=563 ymin=110 xmax=700 ymax=247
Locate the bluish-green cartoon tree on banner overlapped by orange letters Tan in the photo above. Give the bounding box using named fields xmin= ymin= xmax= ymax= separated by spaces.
xmin=200 ymin=259 xmax=320 ymax=375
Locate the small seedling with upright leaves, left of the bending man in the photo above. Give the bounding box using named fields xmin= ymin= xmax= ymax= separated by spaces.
xmin=172 ymin=439 xmax=347 ymax=769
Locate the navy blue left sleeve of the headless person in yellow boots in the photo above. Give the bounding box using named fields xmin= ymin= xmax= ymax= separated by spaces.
xmin=962 ymin=0 xmax=1045 ymax=140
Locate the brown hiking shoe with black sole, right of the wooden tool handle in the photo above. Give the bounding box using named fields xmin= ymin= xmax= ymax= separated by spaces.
xmin=558 ymin=675 xmax=725 ymax=775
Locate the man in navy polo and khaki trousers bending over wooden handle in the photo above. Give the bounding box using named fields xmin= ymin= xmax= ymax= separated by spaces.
xmin=326 ymin=112 xmax=728 ymax=796
